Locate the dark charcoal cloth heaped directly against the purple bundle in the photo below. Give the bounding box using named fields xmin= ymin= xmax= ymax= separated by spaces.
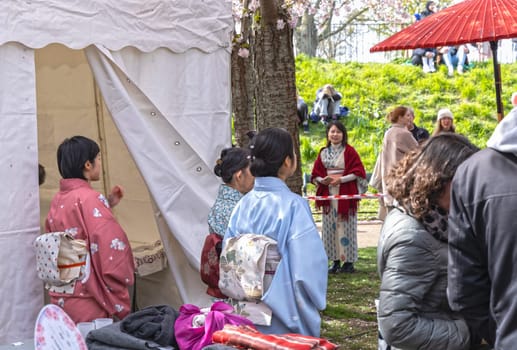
xmin=120 ymin=305 xmax=179 ymax=347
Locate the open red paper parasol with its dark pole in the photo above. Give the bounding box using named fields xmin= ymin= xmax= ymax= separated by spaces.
xmin=370 ymin=0 xmax=517 ymax=120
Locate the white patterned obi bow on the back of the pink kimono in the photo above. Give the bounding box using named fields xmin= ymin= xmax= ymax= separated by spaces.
xmin=33 ymin=232 xmax=88 ymax=293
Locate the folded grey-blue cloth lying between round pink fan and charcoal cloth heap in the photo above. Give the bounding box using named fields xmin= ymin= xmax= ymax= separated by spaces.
xmin=86 ymin=322 xmax=174 ymax=350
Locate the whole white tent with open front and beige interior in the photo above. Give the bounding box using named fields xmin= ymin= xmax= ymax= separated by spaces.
xmin=0 ymin=0 xmax=232 ymax=343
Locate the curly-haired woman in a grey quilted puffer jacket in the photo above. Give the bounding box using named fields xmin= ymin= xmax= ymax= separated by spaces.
xmin=377 ymin=134 xmax=477 ymax=350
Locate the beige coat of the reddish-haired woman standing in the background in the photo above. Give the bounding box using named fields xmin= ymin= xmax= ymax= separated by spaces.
xmin=381 ymin=124 xmax=418 ymax=206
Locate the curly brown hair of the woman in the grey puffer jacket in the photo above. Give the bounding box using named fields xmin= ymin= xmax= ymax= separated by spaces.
xmin=386 ymin=133 xmax=479 ymax=219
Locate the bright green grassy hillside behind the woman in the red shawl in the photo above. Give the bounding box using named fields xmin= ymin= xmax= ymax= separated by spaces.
xmin=296 ymin=56 xmax=517 ymax=172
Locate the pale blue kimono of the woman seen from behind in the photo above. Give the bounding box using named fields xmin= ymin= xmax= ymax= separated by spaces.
xmin=223 ymin=177 xmax=327 ymax=337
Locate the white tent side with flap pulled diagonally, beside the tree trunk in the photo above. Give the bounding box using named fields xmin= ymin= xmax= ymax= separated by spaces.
xmin=86 ymin=43 xmax=231 ymax=302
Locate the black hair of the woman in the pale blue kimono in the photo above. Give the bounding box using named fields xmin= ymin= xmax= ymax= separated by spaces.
xmin=250 ymin=128 xmax=294 ymax=177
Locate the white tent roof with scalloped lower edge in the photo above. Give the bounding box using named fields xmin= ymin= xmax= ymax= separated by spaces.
xmin=0 ymin=0 xmax=232 ymax=53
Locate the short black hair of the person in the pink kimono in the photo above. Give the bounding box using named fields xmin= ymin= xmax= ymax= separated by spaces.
xmin=57 ymin=136 xmax=100 ymax=180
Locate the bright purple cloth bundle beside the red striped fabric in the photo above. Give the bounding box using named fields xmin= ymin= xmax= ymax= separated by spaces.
xmin=174 ymin=301 xmax=255 ymax=350
